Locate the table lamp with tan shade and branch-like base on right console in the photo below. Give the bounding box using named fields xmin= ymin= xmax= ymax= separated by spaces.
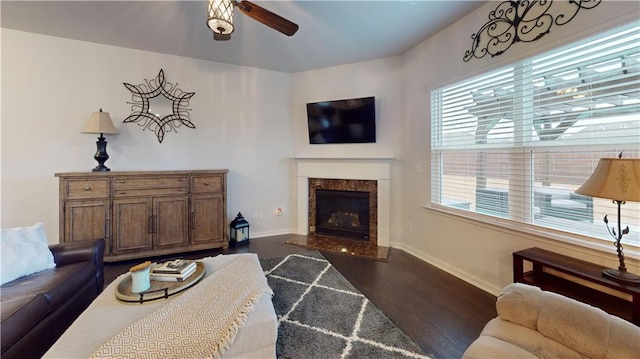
xmin=575 ymin=153 xmax=640 ymax=285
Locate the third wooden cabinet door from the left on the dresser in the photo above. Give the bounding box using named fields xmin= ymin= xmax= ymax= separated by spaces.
xmin=153 ymin=196 xmax=189 ymax=249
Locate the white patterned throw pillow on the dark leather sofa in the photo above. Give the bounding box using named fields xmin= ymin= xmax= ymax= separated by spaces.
xmin=0 ymin=223 xmax=55 ymax=285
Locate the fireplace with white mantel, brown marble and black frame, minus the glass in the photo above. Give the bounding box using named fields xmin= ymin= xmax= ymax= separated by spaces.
xmin=293 ymin=158 xmax=392 ymax=259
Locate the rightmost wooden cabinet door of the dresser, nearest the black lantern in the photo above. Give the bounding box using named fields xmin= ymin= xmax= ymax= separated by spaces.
xmin=191 ymin=194 xmax=225 ymax=244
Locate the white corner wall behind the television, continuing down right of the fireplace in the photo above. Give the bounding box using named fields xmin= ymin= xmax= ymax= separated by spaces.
xmin=291 ymin=57 xmax=402 ymax=246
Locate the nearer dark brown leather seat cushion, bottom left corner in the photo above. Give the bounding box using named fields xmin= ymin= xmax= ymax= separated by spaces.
xmin=0 ymin=296 xmax=49 ymax=348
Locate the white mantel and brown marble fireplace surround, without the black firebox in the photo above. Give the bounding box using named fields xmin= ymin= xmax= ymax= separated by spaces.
xmin=295 ymin=158 xmax=393 ymax=259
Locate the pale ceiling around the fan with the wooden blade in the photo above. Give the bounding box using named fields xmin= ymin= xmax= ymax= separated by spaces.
xmin=0 ymin=0 xmax=484 ymax=72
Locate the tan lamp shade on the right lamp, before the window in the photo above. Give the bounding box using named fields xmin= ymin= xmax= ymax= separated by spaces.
xmin=575 ymin=158 xmax=640 ymax=202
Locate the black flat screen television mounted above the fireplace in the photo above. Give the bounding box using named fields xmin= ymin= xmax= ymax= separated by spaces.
xmin=307 ymin=97 xmax=376 ymax=144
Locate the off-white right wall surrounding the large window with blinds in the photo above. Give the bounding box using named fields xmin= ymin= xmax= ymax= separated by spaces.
xmin=400 ymin=1 xmax=640 ymax=294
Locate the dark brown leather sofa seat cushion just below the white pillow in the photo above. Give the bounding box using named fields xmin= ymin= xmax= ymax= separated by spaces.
xmin=2 ymin=262 xmax=96 ymax=312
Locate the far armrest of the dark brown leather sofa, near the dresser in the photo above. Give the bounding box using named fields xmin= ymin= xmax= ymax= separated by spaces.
xmin=49 ymin=239 xmax=105 ymax=293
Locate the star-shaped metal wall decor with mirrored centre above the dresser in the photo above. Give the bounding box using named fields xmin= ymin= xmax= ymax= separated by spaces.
xmin=123 ymin=69 xmax=196 ymax=143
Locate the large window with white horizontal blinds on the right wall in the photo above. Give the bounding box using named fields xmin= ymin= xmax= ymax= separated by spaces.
xmin=431 ymin=24 xmax=640 ymax=246
